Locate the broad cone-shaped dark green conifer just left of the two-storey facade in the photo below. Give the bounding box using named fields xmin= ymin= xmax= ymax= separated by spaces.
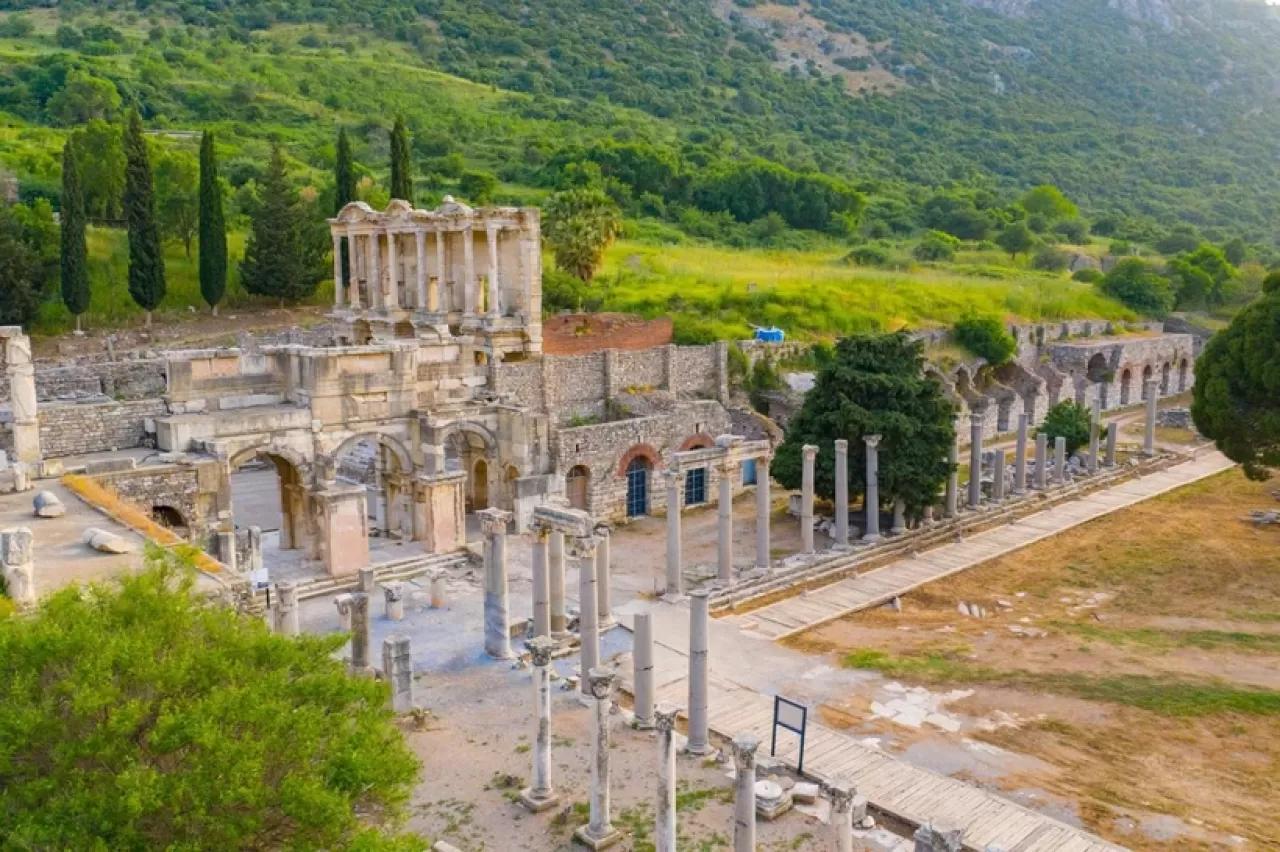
xmin=241 ymin=145 xmax=319 ymax=302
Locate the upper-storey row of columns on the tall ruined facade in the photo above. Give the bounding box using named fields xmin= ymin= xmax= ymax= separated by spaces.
xmin=333 ymin=225 xmax=502 ymax=316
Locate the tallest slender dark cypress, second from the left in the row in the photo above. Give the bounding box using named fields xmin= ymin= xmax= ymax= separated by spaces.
xmin=123 ymin=110 xmax=165 ymax=327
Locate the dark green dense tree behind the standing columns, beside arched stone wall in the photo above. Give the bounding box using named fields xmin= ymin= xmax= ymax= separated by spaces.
xmin=772 ymin=331 xmax=955 ymax=516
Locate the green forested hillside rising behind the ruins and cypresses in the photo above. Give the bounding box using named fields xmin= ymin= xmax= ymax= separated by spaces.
xmin=0 ymin=0 xmax=1280 ymax=241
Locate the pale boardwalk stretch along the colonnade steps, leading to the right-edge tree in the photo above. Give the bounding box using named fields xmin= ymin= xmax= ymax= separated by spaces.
xmin=721 ymin=450 xmax=1233 ymax=637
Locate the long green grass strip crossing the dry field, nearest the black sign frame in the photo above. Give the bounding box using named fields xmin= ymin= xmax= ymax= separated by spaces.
xmin=844 ymin=649 xmax=1280 ymax=716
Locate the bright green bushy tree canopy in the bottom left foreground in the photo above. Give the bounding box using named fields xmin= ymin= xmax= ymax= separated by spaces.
xmin=0 ymin=551 xmax=420 ymax=852
